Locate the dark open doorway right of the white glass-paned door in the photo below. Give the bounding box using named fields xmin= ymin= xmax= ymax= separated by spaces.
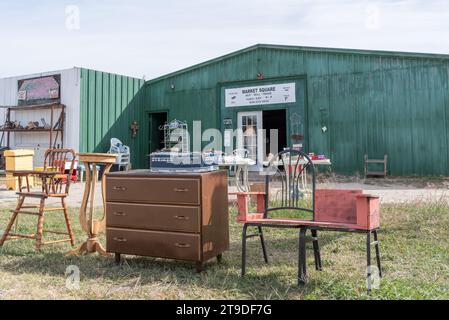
xmin=262 ymin=109 xmax=287 ymax=157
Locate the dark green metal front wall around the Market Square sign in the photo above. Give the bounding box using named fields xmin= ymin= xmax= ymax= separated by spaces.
xmin=142 ymin=45 xmax=449 ymax=175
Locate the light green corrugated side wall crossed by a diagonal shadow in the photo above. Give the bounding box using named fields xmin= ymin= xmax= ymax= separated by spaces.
xmin=80 ymin=69 xmax=146 ymax=167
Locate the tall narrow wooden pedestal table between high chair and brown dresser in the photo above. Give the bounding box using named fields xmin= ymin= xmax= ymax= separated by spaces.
xmin=67 ymin=153 xmax=117 ymax=257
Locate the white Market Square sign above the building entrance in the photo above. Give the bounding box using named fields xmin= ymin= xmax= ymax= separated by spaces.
xmin=225 ymin=83 xmax=296 ymax=108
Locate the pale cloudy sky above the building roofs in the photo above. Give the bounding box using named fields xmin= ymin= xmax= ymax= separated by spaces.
xmin=0 ymin=0 xmax=449 ymax=79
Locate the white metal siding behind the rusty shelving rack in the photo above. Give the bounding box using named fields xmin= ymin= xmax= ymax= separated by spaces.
xmin=0 ymin=68 xmax=80 ymax=166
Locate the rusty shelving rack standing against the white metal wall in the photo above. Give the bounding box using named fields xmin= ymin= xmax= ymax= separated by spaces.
xmin=0 ymin=103 xmax=65 ymax=149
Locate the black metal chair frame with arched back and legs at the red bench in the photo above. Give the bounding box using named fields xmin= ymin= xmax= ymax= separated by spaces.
xmin=242 ymin=149 xmax=322 ymax=285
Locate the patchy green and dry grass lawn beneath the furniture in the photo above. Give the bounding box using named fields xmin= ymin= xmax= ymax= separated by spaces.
xmin=0 ymin=203 xmax=449 ymax=299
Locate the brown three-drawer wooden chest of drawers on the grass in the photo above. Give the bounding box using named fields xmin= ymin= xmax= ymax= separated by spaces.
xmin=106 ymin=170 xmax=229 ymax=271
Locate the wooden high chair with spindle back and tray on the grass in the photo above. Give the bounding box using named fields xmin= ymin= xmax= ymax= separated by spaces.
xmin=0 ymin=149 xmax=76 ymax=251
